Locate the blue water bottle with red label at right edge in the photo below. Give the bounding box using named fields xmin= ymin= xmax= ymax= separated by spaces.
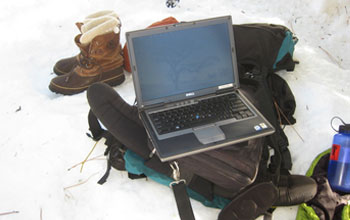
xmin=327 ymin=117 xmax=350 ymax=193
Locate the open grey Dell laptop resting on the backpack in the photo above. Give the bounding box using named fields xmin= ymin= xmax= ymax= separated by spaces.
xmin=126 ymin=16 xmax=275 ymax=162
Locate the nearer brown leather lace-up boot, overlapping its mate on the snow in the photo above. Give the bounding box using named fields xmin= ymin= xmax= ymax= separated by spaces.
xmin=49 ymin=32 xmax=125 ymax=95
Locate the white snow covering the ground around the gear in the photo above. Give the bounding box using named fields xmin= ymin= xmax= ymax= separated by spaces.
xmin=0 ymin=0 xmax=350 ymax=220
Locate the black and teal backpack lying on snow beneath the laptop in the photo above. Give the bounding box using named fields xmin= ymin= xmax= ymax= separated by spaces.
xmin=88 ymin=19 xmax=297 ymax=219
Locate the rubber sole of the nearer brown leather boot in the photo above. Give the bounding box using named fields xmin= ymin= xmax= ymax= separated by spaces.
xmin=49 ymin=73 xmax=125 ymax=95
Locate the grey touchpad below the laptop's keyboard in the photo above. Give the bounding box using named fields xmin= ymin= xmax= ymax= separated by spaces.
xmin=193 ymin=125 xmax=226 ymax=144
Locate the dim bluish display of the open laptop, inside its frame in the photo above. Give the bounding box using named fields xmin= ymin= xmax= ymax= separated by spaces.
xmin=132 ymin=17 xmax=235 ymax=102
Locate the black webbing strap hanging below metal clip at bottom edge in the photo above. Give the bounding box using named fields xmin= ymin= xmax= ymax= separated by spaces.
xmin=172 ymin=181 xmax=195 ymax=220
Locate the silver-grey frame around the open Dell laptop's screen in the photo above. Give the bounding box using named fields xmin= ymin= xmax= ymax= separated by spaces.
xmin=126 ymin=16 xmax=239 ymax=108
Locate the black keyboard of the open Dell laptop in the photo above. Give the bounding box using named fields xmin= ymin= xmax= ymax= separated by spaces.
xmin=150 ymin=93 xmax=254 ymax=134
